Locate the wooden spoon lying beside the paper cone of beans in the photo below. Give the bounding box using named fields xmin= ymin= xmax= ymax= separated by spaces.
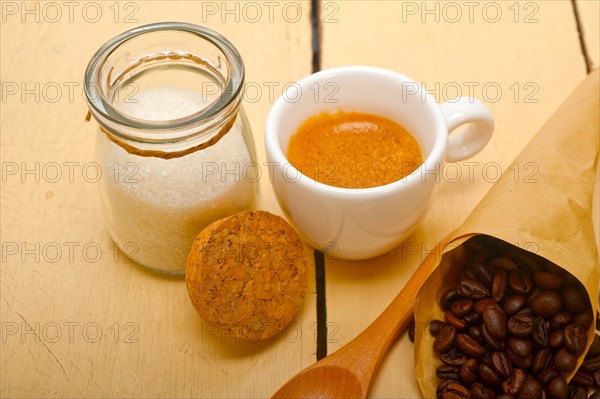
xmin=272 ymin=244 xmax=444 ymax=399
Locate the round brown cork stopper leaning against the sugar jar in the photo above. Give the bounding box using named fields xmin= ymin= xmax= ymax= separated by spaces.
xmin=185 ymin=211 xmax=307 ymax=341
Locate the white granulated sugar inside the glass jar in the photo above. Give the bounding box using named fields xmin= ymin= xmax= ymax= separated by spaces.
xmin=96 ymin=88 xmax=257 ymax=271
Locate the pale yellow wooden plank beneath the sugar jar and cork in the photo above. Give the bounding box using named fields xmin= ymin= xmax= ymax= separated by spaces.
xmin=0 ymin=1 xmax=315 ymax=398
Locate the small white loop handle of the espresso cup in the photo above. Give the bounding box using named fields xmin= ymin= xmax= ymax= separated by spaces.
xmin=441 ymin=97 xmax=494 ymax=162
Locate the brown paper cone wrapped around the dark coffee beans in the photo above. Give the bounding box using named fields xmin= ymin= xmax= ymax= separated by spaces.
xmin=415 ymin=69 xmax=600 ymax=398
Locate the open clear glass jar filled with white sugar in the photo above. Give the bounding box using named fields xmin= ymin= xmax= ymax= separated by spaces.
xmin=85 ymin=22 xmax=258 ymax=274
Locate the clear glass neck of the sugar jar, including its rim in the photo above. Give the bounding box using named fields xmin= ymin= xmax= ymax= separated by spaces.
xmin=85 ymin=22 xmax=244 ymax=152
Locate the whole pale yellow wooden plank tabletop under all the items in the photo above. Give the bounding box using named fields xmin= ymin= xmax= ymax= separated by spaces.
xmin=0 ymin=0 xmax=600 ymax=398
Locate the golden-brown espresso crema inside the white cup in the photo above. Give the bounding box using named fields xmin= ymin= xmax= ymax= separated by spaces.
xmin=287 ymin=111 xmax=423 ymax=188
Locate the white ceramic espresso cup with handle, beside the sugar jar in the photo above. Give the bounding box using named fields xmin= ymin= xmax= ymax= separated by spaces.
xmin=265 ymin=66 xmax=494 ymax=259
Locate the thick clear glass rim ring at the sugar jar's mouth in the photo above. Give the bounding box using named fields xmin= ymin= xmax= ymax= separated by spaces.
xmin=84 ymin=22 xmax=245 ymax=139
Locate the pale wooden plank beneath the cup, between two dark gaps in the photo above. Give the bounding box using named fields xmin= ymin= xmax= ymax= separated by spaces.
xmin=323 ymin=1 xmax=597 ymax=398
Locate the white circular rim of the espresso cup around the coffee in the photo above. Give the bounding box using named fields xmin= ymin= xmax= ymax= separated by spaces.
xmin=265 ymin=65 xmax=448 ymax=196
